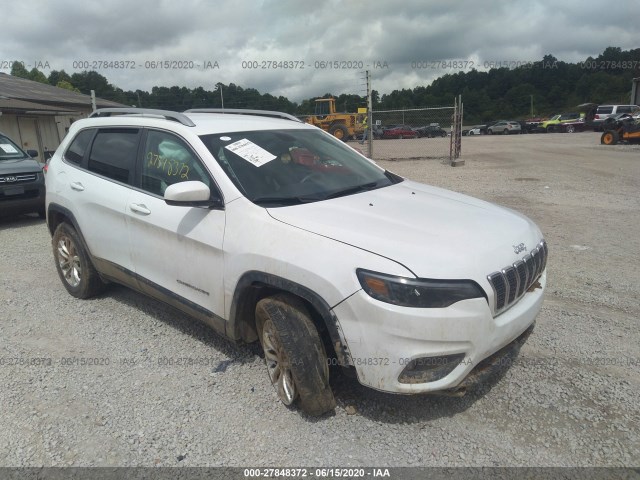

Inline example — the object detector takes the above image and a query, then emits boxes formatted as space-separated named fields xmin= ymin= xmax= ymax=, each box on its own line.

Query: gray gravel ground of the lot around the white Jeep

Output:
xmin=0 ymin=133 xmax=640 ymax=466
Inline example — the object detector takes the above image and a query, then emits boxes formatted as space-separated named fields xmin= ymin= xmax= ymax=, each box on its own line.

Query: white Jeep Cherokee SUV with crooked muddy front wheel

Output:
xmin=46 ymin=109 xmax=547 ymax=415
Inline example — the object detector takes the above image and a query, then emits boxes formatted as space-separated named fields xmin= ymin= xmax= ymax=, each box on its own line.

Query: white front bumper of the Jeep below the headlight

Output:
xmin=334 ymin=271 xmax=546 ymax=394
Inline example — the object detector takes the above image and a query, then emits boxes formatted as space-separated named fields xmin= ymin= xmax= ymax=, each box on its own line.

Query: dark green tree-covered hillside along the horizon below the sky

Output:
xmin=11 ymin=47 xmax=640 ymax=123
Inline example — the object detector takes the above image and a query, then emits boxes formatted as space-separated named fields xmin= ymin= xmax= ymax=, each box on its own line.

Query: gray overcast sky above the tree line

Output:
xmin=0 ymin=0 xmax=640 ymax=101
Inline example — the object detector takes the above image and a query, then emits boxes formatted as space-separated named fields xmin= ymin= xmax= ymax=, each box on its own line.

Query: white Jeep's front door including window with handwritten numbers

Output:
xmin=127 ymin=129 xmax=225 ymax=332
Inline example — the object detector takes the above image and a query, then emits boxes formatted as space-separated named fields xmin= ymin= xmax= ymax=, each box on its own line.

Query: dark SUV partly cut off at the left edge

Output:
xmin=0 ymin=133 xmax=45 ymax=218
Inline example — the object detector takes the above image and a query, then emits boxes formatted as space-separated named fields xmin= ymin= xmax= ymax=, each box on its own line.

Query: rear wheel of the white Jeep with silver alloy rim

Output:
xmin=51 ymin=223 xmax=106 ymax=298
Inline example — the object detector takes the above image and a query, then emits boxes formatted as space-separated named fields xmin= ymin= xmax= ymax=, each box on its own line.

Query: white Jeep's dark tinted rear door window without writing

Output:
xmin=88 ymin=128 xmax=140 ymax=183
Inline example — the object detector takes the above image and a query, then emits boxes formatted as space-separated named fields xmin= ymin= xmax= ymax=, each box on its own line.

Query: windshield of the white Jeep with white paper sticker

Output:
xmin=200 ymin=129 xmax=402 ymax=207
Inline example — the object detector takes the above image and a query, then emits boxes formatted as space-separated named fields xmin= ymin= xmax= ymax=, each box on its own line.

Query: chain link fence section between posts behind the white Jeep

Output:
xmin=356 ymin=106 xmax=454 ymax=160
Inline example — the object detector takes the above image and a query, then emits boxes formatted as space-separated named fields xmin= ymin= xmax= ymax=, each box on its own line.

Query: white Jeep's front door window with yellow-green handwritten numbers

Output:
xmin=140 ymin=130 xmax=211 ymax=196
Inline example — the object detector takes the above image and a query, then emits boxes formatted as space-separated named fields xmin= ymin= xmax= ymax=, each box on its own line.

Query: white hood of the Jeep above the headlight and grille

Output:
xmin=268 ymin=180 xmax=542 ymax=282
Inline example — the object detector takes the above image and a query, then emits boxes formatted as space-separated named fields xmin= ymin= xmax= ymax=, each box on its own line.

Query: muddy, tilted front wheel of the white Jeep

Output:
xmin=256 ymin=294 xmax=336 ymax=416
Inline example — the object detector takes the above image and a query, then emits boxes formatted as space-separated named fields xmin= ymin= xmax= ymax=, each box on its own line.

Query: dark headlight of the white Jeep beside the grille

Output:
xmin=356 ymin=269 xmax=486 ymax=308
